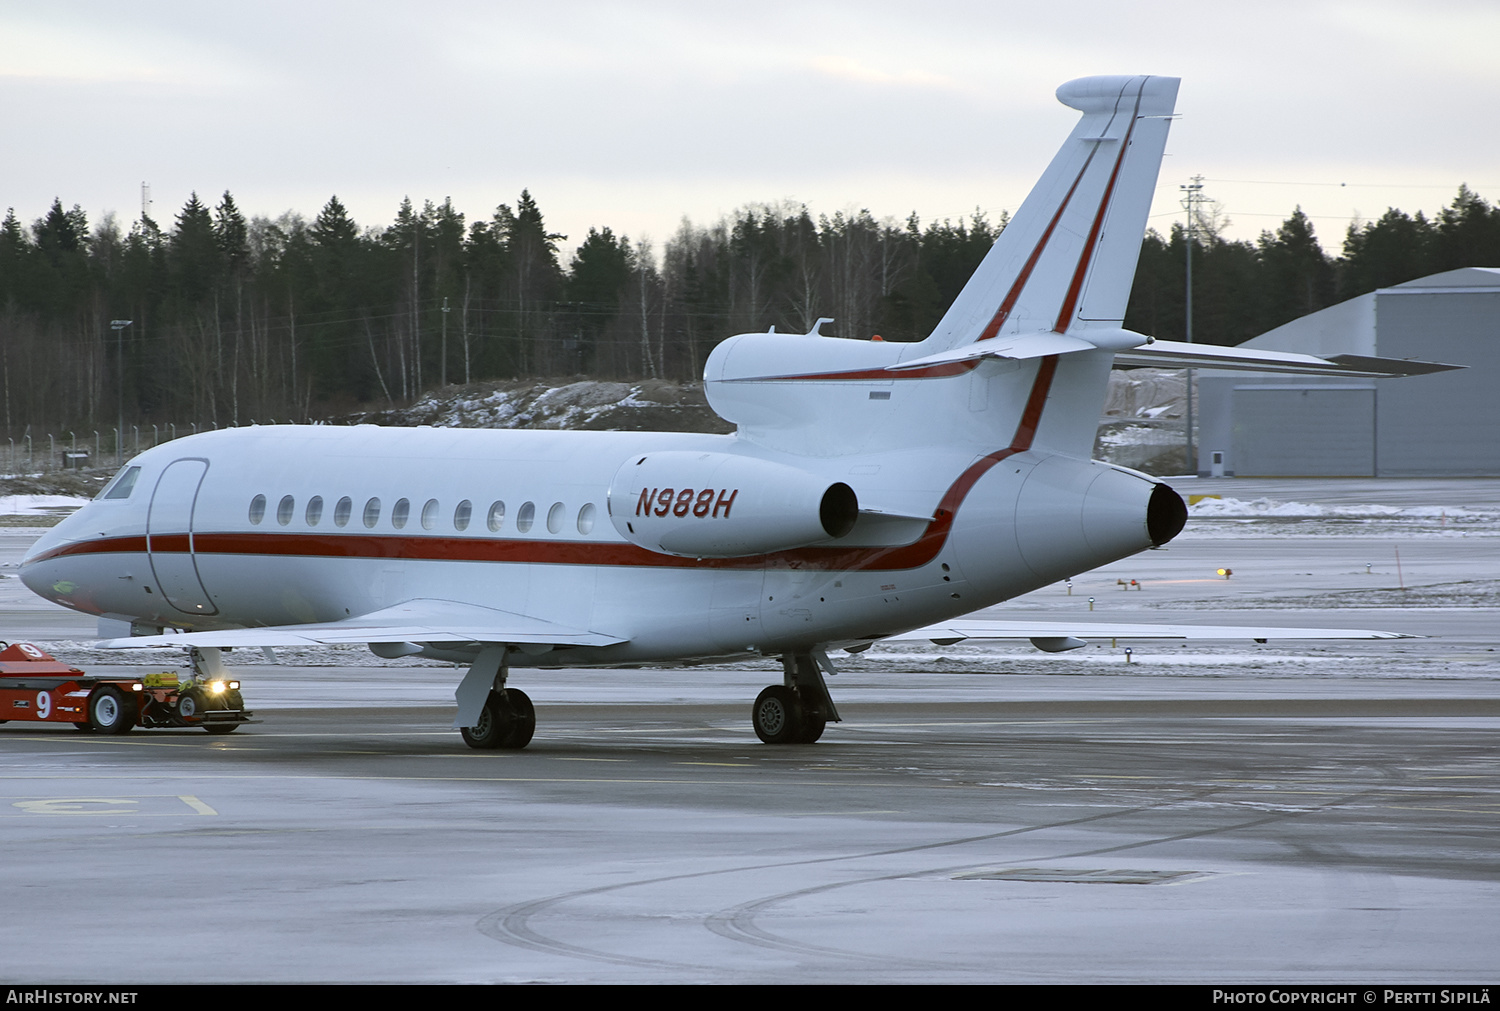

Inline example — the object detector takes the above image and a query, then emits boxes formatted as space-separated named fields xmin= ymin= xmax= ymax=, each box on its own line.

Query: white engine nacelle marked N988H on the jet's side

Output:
xmin=608 ymin=450 xmax=860 ymax=558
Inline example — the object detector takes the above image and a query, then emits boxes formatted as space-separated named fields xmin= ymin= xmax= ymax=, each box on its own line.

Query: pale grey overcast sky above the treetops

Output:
xmin=0 ymin=0 xmax=1500 ymax=259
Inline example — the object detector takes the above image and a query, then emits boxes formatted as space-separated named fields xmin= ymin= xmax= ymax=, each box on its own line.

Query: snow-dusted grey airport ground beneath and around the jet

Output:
xmin=0 ymin=482 xmax=1500 ymax=984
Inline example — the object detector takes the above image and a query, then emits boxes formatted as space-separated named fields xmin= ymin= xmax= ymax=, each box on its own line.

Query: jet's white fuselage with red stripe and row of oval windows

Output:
xmin=23 ymin=408 xmax=1170 ymax=666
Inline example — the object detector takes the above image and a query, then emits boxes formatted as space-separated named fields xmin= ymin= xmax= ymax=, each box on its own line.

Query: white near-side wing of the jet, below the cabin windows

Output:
xmin=99 ymin=600 xmax=627 ymax=650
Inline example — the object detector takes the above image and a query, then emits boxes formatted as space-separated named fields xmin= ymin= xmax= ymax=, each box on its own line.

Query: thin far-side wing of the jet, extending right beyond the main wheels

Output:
xmin=881 ymin=620 xmax=1421 ymax=653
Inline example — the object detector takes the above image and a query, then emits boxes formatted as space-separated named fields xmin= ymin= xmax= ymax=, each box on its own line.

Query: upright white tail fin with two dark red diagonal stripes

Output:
xmin=923 ymin=77 xmax=1178 ymax=354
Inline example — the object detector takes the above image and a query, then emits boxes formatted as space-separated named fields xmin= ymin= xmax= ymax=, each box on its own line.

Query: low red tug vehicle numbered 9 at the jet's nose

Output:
xmin=0 ymin=642 xmax=260 ymax=734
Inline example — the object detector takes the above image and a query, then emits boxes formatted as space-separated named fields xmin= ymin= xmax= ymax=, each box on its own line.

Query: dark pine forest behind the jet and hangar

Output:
xmin=0 ymin=188 xmax=1500 ymax=441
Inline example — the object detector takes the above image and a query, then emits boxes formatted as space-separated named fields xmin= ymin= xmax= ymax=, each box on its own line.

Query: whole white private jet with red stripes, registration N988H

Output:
xmin=21 ymin=77 xmax=1446 ymax=749
